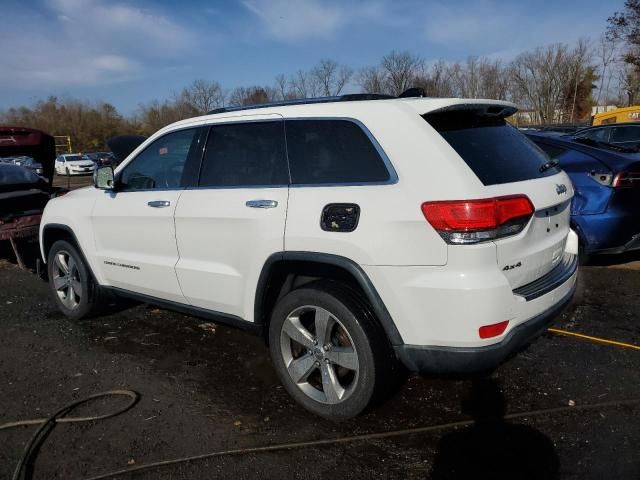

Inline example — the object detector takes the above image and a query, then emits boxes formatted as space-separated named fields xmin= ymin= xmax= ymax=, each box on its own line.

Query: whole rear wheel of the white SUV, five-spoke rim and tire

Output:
xmin=269 ymin=282 xmax=395 ymax=420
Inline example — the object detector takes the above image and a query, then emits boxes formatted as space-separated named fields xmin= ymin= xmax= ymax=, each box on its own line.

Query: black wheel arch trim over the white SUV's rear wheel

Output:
xmin=254 ymin=251 xmax=404 ymax=345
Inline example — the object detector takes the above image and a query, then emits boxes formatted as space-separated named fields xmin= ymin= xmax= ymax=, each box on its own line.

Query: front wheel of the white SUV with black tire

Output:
xmin=47 ymin=240 xmax=101 ymax=320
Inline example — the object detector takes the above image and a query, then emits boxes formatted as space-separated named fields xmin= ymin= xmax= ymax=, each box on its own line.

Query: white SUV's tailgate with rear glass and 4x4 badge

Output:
xmin=425 ymin=111 xmax=573 ymax=288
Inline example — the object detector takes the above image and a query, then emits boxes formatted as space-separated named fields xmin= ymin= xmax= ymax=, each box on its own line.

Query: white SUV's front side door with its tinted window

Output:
xmin=92 ymin=128 xmax=199 ymax=303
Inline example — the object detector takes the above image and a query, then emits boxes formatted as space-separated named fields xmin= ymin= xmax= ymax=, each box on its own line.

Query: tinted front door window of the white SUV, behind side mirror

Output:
xmin=119 ymin=128 xmax=197 ymax=190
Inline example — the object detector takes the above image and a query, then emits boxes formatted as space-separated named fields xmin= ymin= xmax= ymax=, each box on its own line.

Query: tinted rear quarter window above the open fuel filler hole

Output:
xmin=287 ymin=120 xmax=390 ymax=184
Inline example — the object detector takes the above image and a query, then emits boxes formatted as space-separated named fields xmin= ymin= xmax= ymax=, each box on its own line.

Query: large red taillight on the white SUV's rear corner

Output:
xmin=422 ymin=195 xmax=534 ymax=245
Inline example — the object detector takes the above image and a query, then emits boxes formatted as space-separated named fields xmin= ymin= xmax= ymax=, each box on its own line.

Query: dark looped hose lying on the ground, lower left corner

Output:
xmin=0 ymin=390 xmax=140 ymax=480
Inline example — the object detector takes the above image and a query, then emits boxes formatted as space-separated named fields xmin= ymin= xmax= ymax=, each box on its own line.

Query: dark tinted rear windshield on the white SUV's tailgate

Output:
xmin=424 ymin=112 xmax=560 ymax=185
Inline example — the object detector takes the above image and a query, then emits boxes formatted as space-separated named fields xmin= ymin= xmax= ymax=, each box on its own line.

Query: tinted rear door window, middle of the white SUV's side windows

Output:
xmin=200 ymin=122 xmax=289 ymax=187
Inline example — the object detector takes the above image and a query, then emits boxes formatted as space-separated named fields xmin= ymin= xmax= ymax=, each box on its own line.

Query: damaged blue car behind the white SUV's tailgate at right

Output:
xmin=526 ymin=132 xmax=640 ymax=259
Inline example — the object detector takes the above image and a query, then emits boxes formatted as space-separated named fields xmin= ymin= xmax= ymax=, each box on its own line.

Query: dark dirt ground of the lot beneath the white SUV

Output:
xmin=0 ymin=179 xmax=640 ymax=479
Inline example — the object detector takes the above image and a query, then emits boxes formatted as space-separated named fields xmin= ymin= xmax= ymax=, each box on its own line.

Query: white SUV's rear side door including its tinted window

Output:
xmin=175 ymin=115 xmax=289 ymax=320
